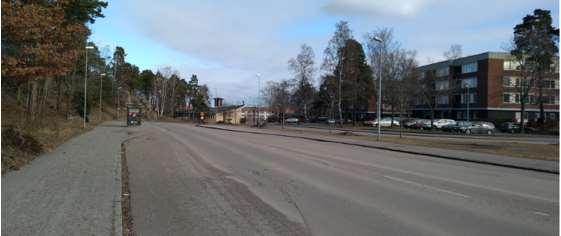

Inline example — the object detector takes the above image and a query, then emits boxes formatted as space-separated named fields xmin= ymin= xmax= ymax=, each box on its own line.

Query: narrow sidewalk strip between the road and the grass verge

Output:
xmin=200 ymin=125 xmax=559 ymax=174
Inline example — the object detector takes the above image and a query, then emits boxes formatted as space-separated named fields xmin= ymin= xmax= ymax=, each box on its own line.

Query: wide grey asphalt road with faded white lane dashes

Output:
xmin=126 ymin=122 xmax=559 ymax=235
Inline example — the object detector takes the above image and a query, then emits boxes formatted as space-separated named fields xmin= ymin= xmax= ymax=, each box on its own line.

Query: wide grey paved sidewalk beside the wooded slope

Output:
xmin=2 ymin=122 xmax=127 ymax=235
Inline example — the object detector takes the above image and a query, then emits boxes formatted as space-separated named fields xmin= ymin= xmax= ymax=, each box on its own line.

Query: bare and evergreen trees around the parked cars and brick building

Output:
xmin=261 ymin=9 xmax=559 ymax=132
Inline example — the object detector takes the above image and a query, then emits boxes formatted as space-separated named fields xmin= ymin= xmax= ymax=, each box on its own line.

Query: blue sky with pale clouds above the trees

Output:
xmin=90 ymin=0 xmax=559 ymax=104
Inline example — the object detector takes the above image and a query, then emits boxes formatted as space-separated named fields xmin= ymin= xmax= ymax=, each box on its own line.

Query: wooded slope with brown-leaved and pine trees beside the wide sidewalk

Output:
xmin=2 ymin=0 xmax=209 ymax=173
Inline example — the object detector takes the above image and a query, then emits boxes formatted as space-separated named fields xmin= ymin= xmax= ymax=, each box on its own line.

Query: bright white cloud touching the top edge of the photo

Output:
xmin=324 ymin=0 xmax=432 ymax=16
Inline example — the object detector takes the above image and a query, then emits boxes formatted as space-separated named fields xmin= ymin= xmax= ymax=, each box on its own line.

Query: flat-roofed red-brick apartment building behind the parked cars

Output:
xmin=411 ymin=52 xmax=559 ymax=122
